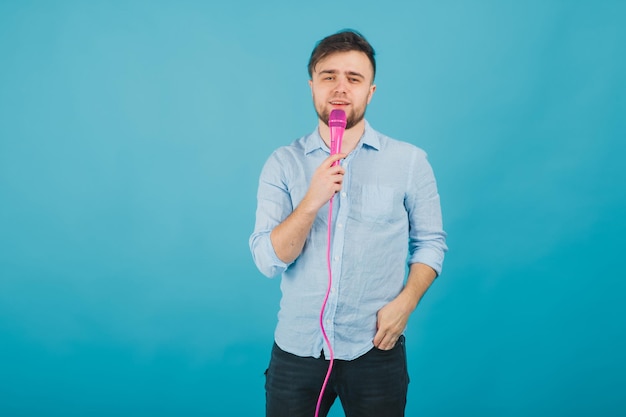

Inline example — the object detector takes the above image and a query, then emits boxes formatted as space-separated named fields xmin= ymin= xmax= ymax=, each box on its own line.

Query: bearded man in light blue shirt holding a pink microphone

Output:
xmin=250 ymin=31 xmax=447 ymax=417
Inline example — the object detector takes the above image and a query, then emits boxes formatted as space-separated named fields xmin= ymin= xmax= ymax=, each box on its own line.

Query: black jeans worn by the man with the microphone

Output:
xmin=265 ymin=336 xmax=409 ymax=417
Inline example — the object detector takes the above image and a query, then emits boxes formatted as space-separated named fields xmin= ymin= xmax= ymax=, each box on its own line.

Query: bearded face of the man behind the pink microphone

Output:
xmin=309 ymin=51 xmax=376 ymax=129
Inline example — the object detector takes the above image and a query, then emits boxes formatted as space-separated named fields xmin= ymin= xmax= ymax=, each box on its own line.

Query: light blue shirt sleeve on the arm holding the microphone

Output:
xmin=249 ymin=152 xmax=293 ymax=278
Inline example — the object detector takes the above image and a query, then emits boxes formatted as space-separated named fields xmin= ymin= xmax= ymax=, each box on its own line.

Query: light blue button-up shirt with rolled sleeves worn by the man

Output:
xmin=250 ymin=122 xmax=447 ymax=360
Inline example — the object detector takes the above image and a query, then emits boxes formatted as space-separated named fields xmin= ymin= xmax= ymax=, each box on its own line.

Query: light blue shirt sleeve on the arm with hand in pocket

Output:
xmin=405 ymin=149 xmax=448 ymax=275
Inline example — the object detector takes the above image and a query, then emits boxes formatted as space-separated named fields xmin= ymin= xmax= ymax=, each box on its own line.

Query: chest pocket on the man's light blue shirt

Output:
xmin=357 ymin=185 xmax=404 ymax=223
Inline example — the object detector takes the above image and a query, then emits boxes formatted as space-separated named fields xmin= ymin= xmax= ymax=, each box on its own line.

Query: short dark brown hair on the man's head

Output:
xmin=308 ymin=29 xmax=376 ymax=81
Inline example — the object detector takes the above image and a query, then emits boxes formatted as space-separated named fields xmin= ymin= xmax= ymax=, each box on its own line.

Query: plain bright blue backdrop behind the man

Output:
xmin=0 ymin=0 xmax=626 ymax=417
